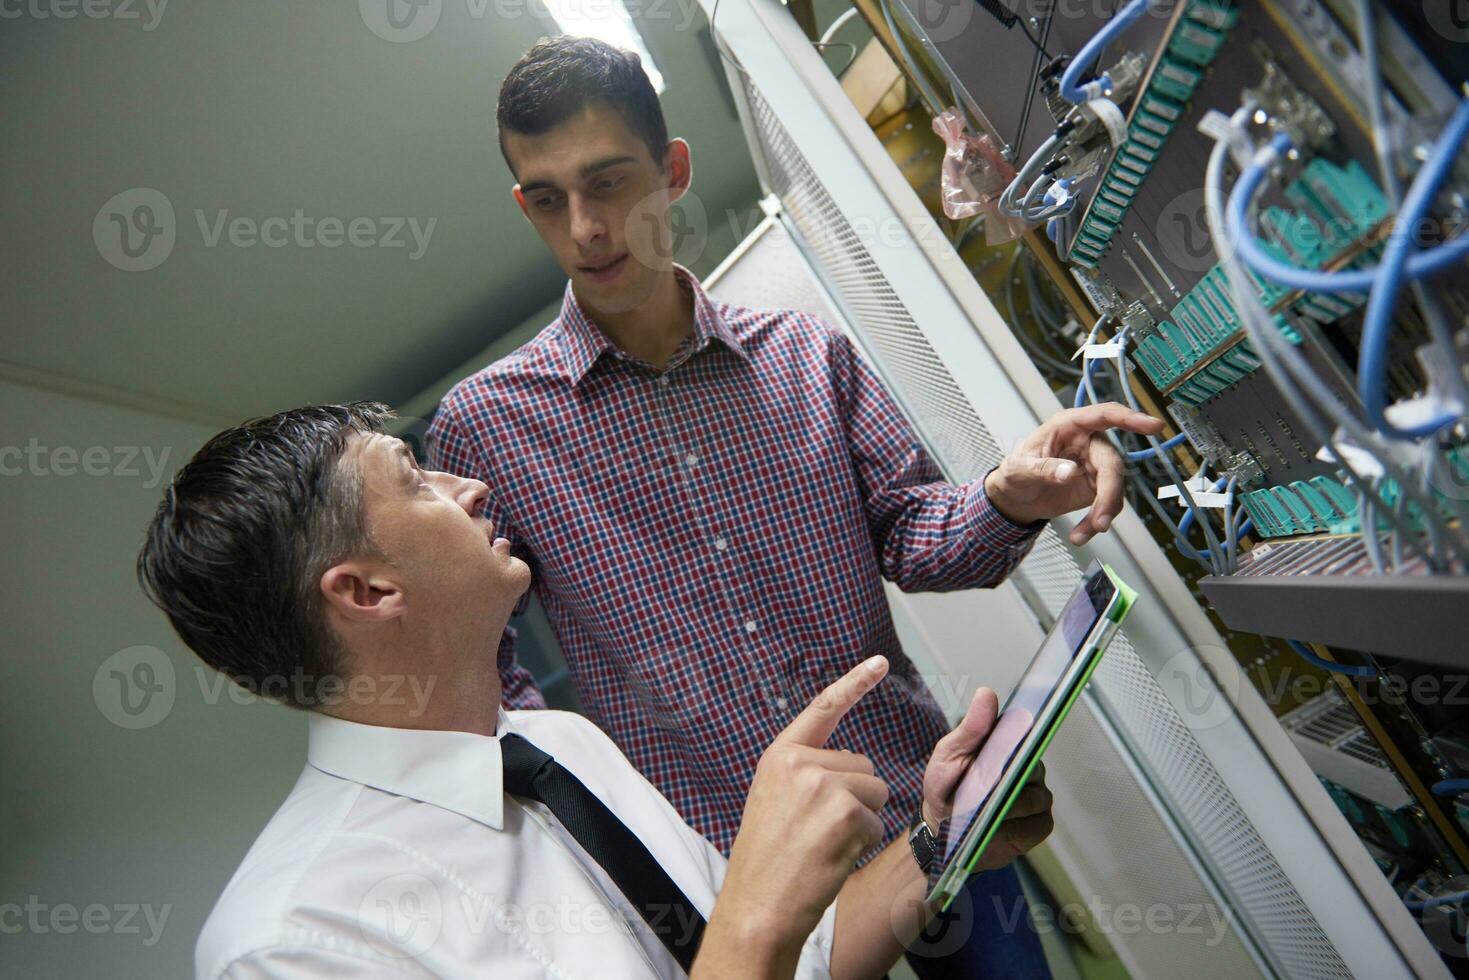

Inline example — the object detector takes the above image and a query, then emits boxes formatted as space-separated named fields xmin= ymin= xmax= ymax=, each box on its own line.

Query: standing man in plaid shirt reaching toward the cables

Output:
xmin=427 ymin=37 xmax=1162 ymax=974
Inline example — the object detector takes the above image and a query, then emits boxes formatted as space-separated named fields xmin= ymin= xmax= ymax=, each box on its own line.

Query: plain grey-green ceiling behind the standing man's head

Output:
xmin=0 ymin=0 xmax=758 ymax=422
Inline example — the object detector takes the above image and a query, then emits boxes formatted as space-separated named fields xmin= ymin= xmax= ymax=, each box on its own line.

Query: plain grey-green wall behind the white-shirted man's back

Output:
xmin=0 ymin=383 xmax=306 ymax=979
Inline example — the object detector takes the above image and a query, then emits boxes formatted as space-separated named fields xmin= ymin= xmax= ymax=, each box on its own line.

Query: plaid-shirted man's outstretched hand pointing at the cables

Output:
xmin=984 ymin=401 xmax=1163 ymax=545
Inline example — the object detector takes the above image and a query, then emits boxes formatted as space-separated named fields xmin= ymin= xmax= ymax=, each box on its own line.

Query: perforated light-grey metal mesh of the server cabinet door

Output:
xmin=739 ymin=73 xmax=1351 ymax=977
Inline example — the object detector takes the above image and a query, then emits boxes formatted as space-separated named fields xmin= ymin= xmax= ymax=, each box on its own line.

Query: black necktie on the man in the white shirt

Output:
xmin=499 ymin=733 xmax=704 ymax=973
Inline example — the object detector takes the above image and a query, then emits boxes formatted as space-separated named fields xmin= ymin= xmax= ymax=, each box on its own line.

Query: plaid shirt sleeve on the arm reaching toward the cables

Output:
xmin=827 ymin=328 xmax=1046 ymax=592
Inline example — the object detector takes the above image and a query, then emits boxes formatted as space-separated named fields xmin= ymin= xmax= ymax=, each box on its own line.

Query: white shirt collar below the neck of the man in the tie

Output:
xmin=306 ymin=710 xmax=510 ymax=830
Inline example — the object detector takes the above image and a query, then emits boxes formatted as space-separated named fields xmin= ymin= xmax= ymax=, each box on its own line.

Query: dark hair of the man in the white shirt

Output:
xmin=138 ymin=401 xmax=394 ymax=708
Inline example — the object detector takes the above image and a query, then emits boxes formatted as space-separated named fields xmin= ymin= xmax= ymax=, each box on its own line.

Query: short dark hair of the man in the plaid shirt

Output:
xmin=495 ymin=34 xmax=668 ymax=173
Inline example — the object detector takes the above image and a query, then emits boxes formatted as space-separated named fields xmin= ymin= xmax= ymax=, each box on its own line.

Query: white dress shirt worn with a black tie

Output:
xmin=194 ymin=711 xmax=836 ymax=980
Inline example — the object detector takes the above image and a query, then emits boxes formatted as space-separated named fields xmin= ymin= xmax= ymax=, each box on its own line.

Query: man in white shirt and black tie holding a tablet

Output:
xmin=138 ymin=403 xmax=1050 ymax=980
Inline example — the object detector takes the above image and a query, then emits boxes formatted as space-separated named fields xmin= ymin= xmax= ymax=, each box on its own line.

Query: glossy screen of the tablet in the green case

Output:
xmin=943 ymin=569 xmax=1112 ymax=864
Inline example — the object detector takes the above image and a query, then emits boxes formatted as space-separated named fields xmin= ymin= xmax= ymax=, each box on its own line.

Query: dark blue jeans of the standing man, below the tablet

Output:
xmin=908 ymin=865 xmax=1050 ymax=980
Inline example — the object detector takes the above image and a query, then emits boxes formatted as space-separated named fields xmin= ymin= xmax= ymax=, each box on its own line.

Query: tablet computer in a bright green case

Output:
xmin=928 ymin=561 xmax=1137 ymax=909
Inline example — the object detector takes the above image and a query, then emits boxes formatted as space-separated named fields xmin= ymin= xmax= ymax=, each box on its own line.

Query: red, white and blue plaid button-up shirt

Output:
xmin=426 ymin=269 xmax=1039 ymax=854
